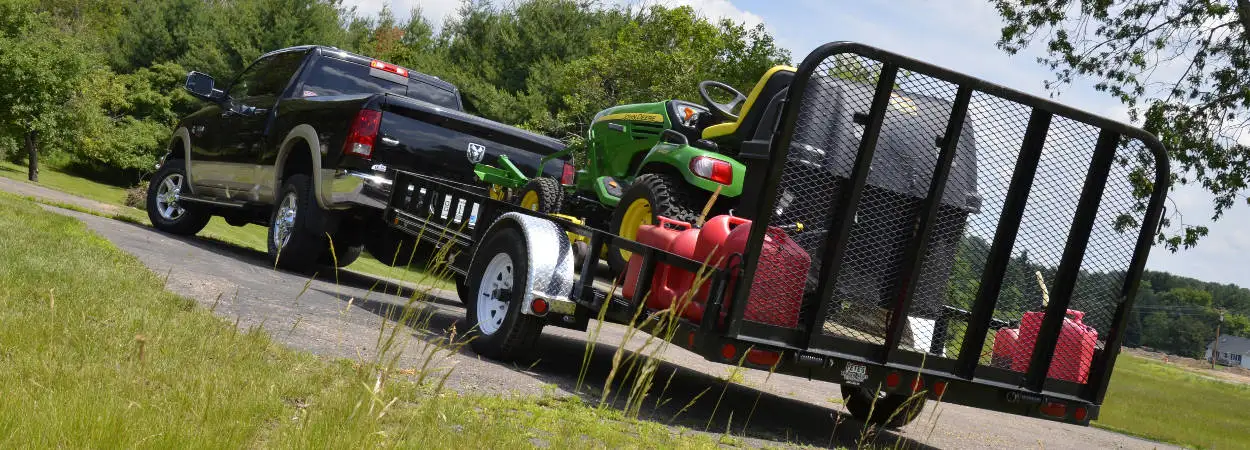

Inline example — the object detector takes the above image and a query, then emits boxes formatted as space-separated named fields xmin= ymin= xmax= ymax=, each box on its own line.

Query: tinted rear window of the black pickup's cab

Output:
xmin=296 ymin=58 xmax=460 ymax=110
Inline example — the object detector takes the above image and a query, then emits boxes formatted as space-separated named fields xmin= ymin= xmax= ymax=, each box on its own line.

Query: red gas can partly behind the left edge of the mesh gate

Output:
xmin=686 ymin=216 xmax=811 ymax=328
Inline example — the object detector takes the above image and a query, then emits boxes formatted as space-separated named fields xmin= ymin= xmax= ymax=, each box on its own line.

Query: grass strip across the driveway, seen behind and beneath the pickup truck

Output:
xmin=0 ymin=161 xmax=455 ymax=290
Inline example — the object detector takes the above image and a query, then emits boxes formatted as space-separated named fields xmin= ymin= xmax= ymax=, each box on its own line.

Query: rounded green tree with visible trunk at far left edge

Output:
xmin=0 ymin=0 xmax=95 ymax=181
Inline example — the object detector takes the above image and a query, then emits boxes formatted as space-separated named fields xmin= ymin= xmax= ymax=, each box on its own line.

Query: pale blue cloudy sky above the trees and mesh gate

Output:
xmin=346 ymin=0 xmax=1250 ymax=286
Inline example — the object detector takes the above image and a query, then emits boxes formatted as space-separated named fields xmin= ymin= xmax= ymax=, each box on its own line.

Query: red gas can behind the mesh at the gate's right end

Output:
xmin=1011 ymin=310 xmax=1098 ymax=384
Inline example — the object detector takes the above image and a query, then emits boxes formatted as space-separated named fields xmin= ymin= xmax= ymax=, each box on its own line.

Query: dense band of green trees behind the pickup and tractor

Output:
xmin=0 ymin=0 xmax=789 ymax=178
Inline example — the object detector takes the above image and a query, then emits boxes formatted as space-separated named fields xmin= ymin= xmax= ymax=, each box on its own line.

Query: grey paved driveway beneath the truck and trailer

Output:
xmin=0 ymin=180 xmax=1166 ymax=449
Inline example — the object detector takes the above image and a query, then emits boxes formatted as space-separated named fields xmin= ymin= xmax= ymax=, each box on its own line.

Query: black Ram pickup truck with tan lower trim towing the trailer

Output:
xmin=146 ymin=46 xmax=564 ymax=269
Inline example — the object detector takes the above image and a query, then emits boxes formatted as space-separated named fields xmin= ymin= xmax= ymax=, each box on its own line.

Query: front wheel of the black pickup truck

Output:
xmin=148 ymin=160 xmax=213 ymax=236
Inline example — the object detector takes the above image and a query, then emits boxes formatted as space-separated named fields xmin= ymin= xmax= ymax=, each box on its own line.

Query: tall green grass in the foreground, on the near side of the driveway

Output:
xmin=0 ymin=194 xmax=716 ymax=449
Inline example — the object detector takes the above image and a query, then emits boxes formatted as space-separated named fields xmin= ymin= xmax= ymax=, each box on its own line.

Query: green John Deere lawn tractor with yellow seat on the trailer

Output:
xmin=475 ymin=66 xmax=795 ymax=274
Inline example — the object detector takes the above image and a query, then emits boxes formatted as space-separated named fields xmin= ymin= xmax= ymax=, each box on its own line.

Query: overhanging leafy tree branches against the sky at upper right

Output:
xmin=993 ymin=0 xmax=1250 ymax=251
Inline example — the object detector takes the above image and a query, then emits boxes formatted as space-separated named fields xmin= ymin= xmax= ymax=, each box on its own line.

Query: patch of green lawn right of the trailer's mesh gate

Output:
xmin=1094 ymin=354 xmax=1250 ymax=449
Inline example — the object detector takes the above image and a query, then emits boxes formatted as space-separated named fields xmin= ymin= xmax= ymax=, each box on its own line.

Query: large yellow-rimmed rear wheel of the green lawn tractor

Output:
xmin=608 ymin=174 xmax=703 ymax=275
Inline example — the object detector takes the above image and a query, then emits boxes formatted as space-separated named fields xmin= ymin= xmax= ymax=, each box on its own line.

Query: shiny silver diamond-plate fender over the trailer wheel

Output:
xmin=470 ymin=213 xmax=576 ymax=315
